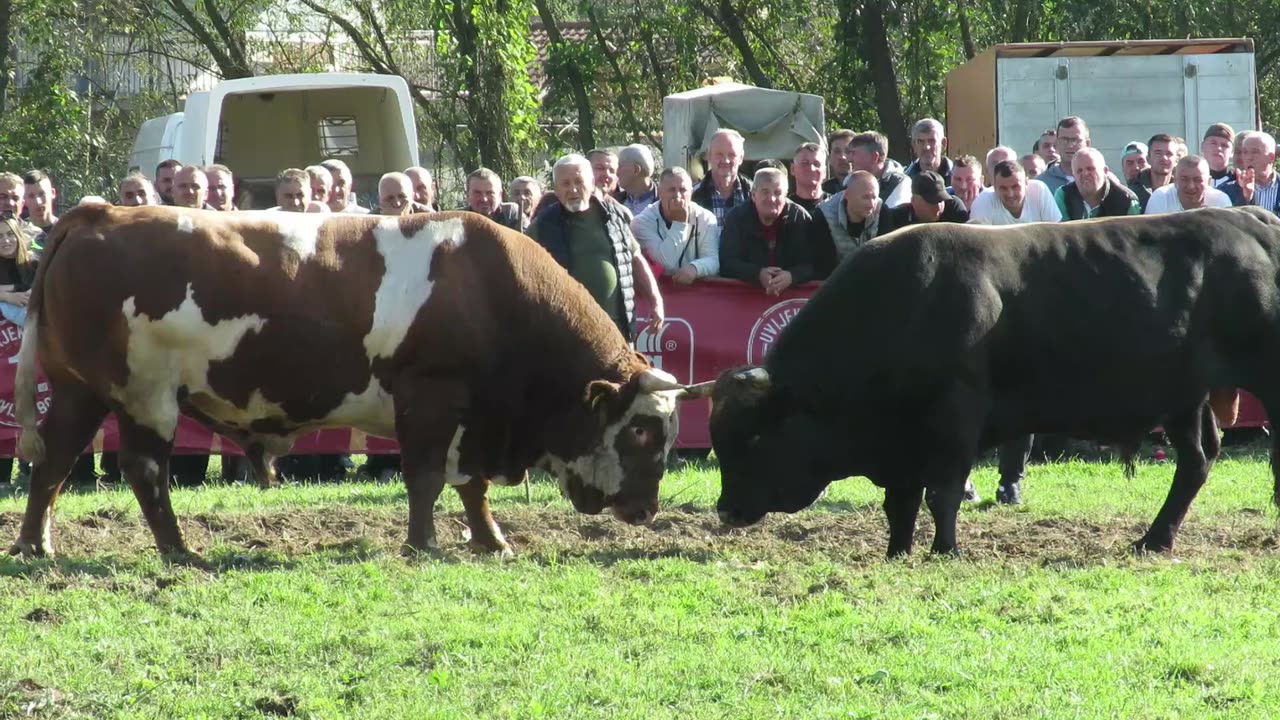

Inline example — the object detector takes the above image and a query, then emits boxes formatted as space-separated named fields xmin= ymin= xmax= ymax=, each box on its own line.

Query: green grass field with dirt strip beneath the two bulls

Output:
xmin=0 ymin=448 xmax=1280 ymax=720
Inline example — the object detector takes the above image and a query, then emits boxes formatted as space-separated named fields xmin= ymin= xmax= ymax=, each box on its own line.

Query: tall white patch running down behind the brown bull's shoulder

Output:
xmin=365 ymin=212 xmax=462 ymax=360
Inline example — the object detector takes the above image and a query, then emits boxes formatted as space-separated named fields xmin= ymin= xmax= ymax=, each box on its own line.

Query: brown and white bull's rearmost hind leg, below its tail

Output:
xmin=9 ymin=384 xmax=108 ymax=557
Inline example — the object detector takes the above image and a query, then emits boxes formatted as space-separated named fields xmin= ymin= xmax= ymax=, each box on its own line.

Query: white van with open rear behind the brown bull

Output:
xmin=129 ymin=73 xmax=419 ymax=209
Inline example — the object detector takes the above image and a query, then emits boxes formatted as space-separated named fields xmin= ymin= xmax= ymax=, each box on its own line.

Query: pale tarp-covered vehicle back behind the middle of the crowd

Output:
xmin=662 ymin=83 xmax=827 ymax=175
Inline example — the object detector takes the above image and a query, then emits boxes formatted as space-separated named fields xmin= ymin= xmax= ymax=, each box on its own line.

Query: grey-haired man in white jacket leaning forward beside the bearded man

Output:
xmin=631 ymin=167 xmax=721 ymax=284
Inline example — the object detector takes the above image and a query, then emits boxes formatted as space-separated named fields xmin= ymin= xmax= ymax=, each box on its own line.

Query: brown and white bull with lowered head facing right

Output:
xmin=12 ymin=205 xmax=711 ymax=555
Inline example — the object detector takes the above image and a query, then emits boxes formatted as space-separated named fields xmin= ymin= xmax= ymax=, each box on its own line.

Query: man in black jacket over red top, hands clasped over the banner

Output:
xmin=719 ymin=168 xmax=835 ymax=295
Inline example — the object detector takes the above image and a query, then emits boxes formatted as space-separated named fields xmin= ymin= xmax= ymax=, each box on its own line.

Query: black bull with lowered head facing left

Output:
xmin=710 ymin=208 xmax=1280 ymax=555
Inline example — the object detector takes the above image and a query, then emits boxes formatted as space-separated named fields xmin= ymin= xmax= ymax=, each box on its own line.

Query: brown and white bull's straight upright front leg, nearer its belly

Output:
xmin=392 ymin=375 xmax=466 ymax=553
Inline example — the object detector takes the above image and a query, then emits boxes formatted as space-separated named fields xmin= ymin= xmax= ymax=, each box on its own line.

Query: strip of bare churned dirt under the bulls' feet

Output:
xmin=0 ymin=505 xmax=1277 ymax=571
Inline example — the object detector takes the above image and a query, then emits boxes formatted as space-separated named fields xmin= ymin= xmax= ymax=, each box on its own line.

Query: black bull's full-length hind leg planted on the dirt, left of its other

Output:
xmin=1134 ymin=402 xmax=1221 ymax=552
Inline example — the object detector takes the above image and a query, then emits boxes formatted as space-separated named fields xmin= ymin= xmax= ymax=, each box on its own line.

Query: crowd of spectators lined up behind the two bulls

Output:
xmin=0 ymin=117 xmax=1280 ymax=487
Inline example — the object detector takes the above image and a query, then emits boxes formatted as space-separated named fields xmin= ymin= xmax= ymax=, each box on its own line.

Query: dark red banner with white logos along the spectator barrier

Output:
xmin=0 ymin=279 xmax=1267 ymax=457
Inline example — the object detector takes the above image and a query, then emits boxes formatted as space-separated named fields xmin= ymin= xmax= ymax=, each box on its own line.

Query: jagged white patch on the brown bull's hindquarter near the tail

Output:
xmin=111 ymin=283 xmax=266 ymax=439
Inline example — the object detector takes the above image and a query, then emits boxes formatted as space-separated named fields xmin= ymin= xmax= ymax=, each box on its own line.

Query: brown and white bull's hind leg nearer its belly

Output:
xmin=116 ymin=414 xmax=191 ymax=556
